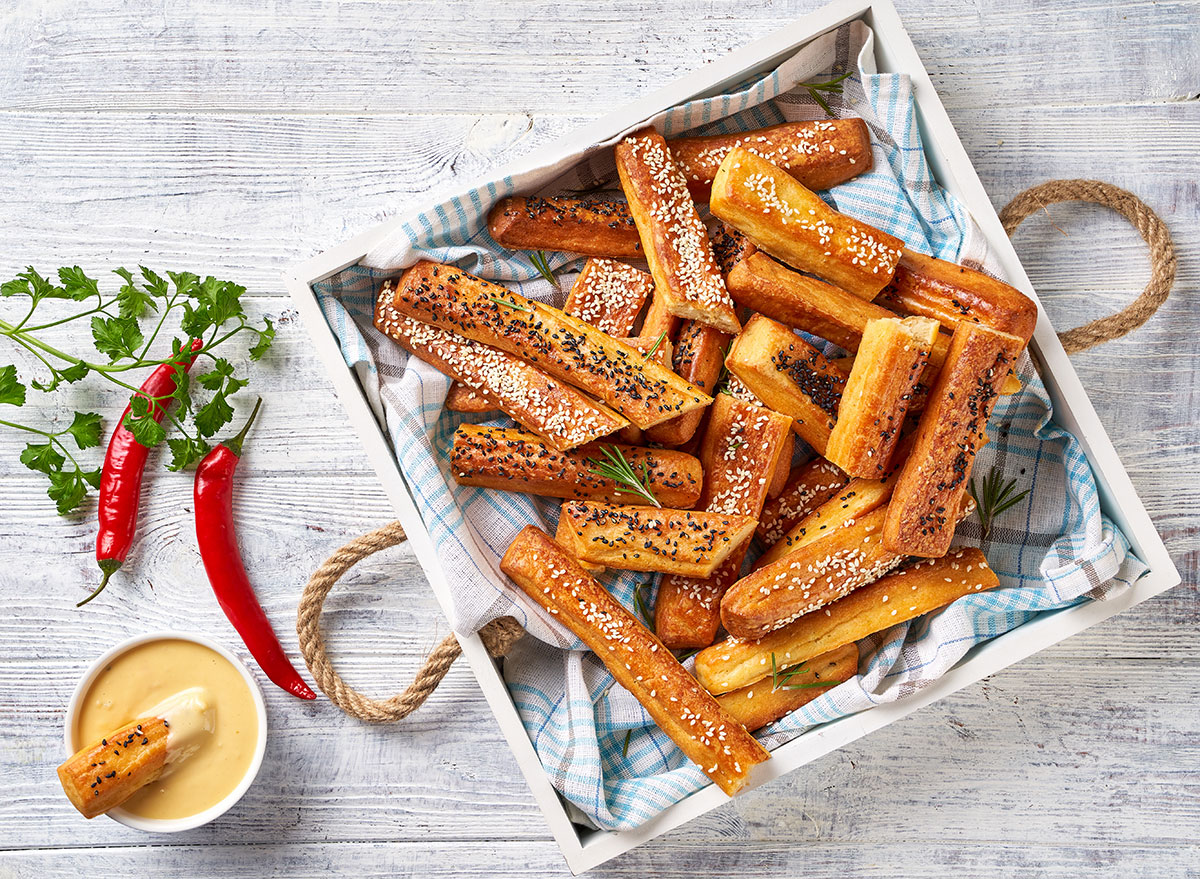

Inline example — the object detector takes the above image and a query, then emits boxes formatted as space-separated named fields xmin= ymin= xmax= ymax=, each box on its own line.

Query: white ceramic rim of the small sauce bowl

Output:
xmin=62 ymin=632 xmax=266 ymax=833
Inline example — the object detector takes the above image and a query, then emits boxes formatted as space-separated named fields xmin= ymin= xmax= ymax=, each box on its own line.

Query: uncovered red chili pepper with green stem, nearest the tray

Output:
xmin=196 ymin=400 xmax=317 ymax=699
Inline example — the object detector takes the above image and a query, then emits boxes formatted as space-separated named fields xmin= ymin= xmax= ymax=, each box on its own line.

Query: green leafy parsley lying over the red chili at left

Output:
xmin=0 ymin=265 xmax=275 ymax=515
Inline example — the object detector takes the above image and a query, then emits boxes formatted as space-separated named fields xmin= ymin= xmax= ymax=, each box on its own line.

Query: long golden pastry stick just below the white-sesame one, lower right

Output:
xmin=696 ymin=548 xmax=1000 ymax=693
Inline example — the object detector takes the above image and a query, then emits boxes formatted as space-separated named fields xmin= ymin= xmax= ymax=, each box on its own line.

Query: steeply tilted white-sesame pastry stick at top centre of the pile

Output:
xmin=616 ymin=128 xmax=742 ymax=333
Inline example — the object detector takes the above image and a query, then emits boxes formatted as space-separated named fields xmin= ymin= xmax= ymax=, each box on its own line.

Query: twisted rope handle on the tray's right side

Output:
xmin=1000 ymin=180 xmax=1176 ymax=354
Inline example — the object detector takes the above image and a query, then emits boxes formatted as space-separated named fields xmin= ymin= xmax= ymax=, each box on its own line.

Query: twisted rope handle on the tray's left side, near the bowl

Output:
xmin=296 ymin=522 xmax=524 ymax=723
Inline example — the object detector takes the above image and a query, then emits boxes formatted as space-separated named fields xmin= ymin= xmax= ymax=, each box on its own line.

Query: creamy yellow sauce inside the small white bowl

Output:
xmin=72 ymin=639 xmax=258 ymax=818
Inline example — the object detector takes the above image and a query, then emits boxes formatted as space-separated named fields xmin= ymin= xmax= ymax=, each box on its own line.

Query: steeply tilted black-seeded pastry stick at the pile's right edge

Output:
xmin=883 ymin=322 xmax=1025 ymax=558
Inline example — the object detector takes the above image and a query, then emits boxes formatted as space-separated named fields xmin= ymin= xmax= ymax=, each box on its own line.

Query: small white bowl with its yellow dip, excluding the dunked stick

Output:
xmin=64 ymin=632 xmax=266 ymax=833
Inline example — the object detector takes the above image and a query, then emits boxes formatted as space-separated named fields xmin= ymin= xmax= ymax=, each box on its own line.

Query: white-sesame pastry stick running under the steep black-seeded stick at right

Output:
xmin=721 ymin=497 xmax=974 ymax=638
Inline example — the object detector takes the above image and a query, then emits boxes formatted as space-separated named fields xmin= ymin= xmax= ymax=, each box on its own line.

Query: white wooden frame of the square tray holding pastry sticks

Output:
xmin=286 ymin=0 xmax=1180 ymax=873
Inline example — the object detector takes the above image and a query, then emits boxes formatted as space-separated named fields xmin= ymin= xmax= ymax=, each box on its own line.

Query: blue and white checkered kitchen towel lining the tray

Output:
xmin=314 ymin=22 xmax=1145 ymax=830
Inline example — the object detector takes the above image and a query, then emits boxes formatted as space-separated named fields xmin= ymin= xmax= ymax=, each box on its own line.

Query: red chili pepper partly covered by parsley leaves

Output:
xmin=85 ymin=339 xmax=204 ymax=608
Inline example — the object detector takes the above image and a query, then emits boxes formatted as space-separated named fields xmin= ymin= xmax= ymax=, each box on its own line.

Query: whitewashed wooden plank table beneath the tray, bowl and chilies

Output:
xmin=0 ymin=0 xmax=1200 ymax=878
